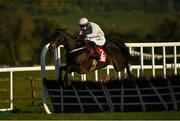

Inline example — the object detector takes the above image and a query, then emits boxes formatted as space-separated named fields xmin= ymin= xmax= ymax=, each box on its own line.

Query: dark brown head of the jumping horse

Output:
xmin=49 ymin=28 xmax=66 ymax=49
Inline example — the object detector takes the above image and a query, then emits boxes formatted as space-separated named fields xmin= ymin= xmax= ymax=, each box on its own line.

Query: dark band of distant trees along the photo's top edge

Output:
xmin=0 ymin=0 xmax=180 ymax=12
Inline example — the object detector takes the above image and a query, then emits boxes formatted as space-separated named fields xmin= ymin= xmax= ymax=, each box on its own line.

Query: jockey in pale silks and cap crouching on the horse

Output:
xmin=79 ymin=18 xmax=106 ymax=61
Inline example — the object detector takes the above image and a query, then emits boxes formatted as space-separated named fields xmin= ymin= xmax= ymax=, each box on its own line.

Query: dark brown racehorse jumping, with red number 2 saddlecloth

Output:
xmin=49 ymin=28 xmax=136 ymax=85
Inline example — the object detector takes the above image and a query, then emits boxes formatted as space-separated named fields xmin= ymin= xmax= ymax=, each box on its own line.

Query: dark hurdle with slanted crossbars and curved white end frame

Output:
xmin=41 ymin=44 xmax=180 ymax=114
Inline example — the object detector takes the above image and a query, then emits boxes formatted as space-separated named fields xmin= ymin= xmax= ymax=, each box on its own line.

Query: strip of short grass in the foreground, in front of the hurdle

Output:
xmin=0 ymin=112 xmax=180 ymax=120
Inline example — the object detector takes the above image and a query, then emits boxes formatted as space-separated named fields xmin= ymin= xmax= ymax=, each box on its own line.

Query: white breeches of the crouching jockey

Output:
xmin=88 ymin=36 xmax=106 ymax=46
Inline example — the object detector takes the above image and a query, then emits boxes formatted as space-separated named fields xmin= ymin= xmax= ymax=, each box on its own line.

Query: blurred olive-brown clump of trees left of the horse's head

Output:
xmin=0 ymin=11 xmax=57 ymax=65
